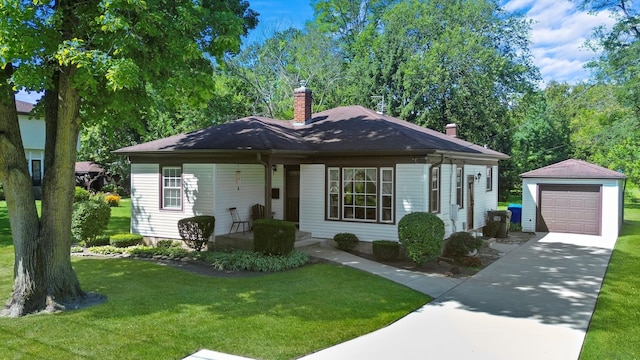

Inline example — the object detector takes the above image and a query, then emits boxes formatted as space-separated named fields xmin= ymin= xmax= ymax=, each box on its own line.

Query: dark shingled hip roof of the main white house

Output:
xmin=115 ymin=106 xmax=508 ymax=159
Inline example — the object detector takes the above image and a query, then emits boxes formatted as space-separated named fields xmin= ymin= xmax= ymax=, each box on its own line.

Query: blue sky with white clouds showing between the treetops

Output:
xmin=16 ymin=0 xmax=614 ymax=103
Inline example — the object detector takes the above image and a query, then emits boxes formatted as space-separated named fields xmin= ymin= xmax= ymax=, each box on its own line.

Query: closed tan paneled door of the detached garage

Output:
xmin=536 ymin=185 xmax=602 ymax=235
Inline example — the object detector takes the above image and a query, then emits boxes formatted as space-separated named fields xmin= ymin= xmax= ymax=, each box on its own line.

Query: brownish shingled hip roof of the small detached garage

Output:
xmin=520 ymin=159 xmax=626 ymax=179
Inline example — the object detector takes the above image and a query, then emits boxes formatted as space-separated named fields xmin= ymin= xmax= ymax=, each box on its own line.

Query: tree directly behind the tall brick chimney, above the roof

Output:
xmin=227 ymin=28 xmax=344 ymax=119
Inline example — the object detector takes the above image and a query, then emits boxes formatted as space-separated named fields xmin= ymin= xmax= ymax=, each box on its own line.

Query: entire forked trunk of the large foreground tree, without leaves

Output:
xmin=0 ymin=68 xmax=95 ymax=317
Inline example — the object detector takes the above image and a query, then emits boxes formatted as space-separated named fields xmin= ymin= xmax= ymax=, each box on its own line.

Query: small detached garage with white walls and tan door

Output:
xmin=520 ymin=159 xmax=626 ymax=237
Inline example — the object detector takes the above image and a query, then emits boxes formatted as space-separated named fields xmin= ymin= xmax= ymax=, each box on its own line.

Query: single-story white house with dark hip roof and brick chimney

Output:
xmin=115 ymin=87 xmax=508 ymax=241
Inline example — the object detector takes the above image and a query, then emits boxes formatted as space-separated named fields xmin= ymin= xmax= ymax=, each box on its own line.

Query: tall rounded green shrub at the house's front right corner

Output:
xmin=398 ymin=212 xmax=444 ymax=266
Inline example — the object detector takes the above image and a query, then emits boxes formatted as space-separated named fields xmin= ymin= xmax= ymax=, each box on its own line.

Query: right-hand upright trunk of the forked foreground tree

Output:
xmin=40 ymin=67 xmax=85 ymax=307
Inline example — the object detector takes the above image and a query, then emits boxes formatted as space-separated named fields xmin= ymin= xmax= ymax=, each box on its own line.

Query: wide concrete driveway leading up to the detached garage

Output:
xmin=303 ymin=233 xmax=616 ymax=360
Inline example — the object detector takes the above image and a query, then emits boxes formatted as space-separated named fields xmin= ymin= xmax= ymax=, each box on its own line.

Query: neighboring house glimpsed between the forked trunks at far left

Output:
xmin=16 ymin=100 xmax=46 ymax=195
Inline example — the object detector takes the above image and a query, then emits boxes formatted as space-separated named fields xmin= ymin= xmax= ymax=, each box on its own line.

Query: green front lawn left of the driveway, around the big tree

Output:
xmin=0 ymin=198 xmax=430 ymax=359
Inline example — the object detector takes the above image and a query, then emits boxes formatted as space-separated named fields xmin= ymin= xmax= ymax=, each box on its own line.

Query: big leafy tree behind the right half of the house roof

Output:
xmin=347 ymin=0 xmax=538 ymax=151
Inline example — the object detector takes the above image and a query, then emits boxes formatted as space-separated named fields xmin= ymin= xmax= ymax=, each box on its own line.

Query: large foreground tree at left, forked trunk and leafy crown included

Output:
xmin=0 ymin=0 xmax=257 ymax=316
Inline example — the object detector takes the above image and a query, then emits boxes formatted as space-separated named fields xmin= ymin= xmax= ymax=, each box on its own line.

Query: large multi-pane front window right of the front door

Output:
xmin=327 ymin=167 xmax=394 ymax=223
